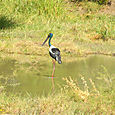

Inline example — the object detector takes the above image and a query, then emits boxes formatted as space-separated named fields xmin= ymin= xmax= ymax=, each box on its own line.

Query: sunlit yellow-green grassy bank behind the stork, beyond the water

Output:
xmin=0 ymin=0 xmax=115 ymax=59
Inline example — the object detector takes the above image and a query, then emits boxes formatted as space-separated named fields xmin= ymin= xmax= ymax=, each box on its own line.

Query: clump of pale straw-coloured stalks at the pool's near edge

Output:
xmin=63 ymin=76 xmax=100 ymax=102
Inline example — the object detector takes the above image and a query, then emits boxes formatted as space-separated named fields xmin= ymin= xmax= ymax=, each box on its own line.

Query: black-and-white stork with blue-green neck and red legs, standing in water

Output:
xmin=42 ymin=33 xmax=62 ymax=78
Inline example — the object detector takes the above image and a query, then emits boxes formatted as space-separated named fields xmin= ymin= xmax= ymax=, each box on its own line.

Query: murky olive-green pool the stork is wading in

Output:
xmin=0 ymin=55 xmax=115 ymax=96
